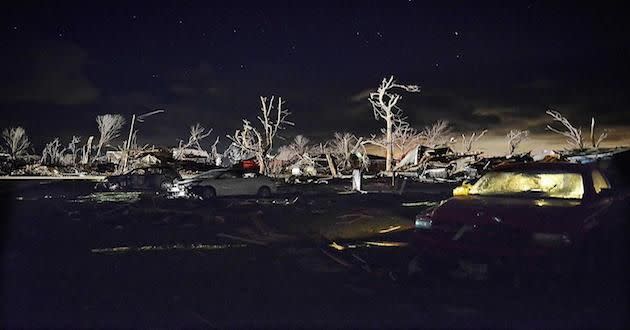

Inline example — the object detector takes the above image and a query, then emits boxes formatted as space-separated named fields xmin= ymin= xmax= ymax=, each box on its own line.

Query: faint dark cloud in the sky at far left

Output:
xmin=0 ymin=42 xmax=100 ymax=105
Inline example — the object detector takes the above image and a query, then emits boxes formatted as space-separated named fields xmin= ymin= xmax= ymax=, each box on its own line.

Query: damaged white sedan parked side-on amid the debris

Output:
xmin=170 ymin=169 xmax=278 ymax=199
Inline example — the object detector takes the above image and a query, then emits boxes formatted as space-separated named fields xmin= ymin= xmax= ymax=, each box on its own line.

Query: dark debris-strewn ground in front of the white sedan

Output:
xmin=1 ymin=182 xmax=628 ymax=329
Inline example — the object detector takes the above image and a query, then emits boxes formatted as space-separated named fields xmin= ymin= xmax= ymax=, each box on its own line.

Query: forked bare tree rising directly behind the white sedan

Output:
xmin=227 ymin=96 xmax=293 ymax=173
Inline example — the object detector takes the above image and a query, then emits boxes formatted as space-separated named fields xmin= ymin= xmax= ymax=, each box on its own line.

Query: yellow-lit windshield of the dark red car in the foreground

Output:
xmin=469 ymin=172 xmax=584 ymax=199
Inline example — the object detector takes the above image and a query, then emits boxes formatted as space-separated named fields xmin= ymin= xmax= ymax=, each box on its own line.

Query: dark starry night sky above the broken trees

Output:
xmin=0 ymin=1 xmax=630 ymax=152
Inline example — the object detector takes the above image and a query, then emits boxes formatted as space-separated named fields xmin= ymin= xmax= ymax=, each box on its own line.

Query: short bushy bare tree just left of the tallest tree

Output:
xmin=326 ymin=132 xmax=369 ymax=171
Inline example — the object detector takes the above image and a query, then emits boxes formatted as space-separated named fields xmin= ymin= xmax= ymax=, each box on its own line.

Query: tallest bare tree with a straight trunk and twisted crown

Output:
xmin=368 ymin=76 xmax=420 ymax=172
